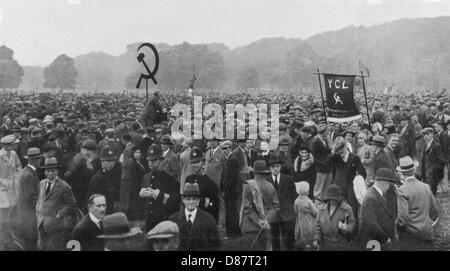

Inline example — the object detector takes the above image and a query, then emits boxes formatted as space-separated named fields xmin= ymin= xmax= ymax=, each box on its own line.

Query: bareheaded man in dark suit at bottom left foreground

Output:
xmin=72 ymin=194 xmax=106 ymax=251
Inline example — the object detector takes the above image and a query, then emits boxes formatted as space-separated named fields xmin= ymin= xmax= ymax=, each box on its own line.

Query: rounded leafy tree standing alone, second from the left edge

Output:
xmin=44 ymin=54 xmax=77 ymax=91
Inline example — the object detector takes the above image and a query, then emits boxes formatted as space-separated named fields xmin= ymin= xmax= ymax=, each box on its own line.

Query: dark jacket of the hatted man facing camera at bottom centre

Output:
xmin=169 ymin=209 xmax=220 ymax=251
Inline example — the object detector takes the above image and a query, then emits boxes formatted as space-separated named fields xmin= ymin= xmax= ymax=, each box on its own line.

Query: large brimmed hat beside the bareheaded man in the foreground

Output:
xmin=97 ymin=213 xmax=141 ymax=239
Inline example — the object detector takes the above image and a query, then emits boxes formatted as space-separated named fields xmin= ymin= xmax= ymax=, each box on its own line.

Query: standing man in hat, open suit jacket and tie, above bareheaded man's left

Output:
xmin=36 ymin=157 xmax=75 ymax=250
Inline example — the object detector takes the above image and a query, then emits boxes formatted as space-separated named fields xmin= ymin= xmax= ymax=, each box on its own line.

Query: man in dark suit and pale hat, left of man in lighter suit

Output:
xmin=17 ymin=148 xmax=42 ymax=251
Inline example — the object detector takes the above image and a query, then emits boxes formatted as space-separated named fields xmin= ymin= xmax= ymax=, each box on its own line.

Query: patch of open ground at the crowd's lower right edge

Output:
xmin=434 ymin=192 xmax=450 ymax=251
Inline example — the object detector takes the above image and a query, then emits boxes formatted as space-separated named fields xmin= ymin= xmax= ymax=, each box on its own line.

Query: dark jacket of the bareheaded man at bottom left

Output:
xmin=72 ymin=214 xmax=105 ymax=251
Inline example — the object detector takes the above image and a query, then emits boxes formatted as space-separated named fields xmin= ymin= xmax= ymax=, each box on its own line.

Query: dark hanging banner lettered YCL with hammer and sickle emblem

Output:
xmin=323 ymin=74 xmax=362 ymax=122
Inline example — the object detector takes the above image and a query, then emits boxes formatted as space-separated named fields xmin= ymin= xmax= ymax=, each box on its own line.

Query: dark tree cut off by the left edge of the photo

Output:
xmin=0 ymin=45 xmax=23 ymax=88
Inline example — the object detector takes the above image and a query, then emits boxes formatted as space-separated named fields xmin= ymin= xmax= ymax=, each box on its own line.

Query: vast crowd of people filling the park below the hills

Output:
xmin=0 ymin=90 xmax=450 ymax=251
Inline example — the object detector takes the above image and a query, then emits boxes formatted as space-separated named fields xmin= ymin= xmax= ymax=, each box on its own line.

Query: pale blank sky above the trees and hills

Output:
xmin=0 ymin=0 xmax=450 ymax=66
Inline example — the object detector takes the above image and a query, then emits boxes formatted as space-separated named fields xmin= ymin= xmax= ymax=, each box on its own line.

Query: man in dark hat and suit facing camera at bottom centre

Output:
xmin=169 ymin=183 xmax=220 ymax=251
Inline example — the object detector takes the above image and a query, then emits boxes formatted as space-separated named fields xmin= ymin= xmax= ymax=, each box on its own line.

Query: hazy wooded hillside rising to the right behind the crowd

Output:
xmin=22 ymin=17 xmax=450 ymax=90
